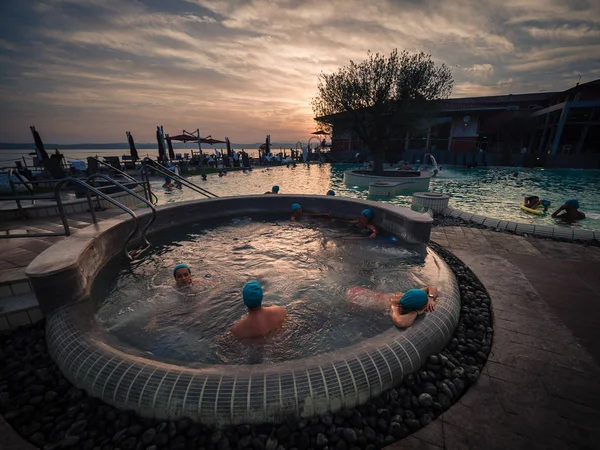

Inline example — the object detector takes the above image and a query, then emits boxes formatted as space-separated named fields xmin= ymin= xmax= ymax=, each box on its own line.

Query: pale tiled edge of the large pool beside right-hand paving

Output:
xmin=439 ymin=207 xmax=600 ymax=242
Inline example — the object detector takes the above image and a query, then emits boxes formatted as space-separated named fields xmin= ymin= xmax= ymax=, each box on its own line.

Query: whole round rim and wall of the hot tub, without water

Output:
xmin=27 ymin=195 xmax=460 ymax=426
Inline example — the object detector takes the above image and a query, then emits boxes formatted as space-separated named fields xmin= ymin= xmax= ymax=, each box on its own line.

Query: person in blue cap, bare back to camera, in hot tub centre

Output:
xmin=231 ymin=280 xmax=287 ymax=339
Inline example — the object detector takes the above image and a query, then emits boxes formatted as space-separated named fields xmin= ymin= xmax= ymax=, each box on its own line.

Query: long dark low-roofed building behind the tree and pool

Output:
xmin=328 ymin=80 xmax=600 ymax=168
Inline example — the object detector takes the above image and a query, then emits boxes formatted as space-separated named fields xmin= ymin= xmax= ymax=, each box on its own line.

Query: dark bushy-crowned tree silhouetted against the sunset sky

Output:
xmin=312 ymin=49 xmax=453 ymax=174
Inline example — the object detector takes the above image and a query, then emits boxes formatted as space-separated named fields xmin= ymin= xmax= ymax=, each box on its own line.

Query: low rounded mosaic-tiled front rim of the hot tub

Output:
xmin=47 ymin=252 xmax=460 ymax=426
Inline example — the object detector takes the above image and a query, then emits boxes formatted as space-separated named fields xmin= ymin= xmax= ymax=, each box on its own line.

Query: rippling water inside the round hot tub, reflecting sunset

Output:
xmin=93 ymin=219 xmax=437 ymax=364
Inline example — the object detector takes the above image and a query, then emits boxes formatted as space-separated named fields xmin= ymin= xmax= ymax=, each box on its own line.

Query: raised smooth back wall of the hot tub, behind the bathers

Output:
xmin=26 ymin=195 xmax=433 ymax=315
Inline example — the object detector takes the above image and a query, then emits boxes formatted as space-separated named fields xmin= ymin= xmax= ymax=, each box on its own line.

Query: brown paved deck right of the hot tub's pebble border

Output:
xmin=388 ymin=227 xmax=600 ymax=450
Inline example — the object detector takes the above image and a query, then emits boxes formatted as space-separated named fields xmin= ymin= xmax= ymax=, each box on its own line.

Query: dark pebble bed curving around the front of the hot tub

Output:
xmin=0 ymin=244 xmax=493 ymax=450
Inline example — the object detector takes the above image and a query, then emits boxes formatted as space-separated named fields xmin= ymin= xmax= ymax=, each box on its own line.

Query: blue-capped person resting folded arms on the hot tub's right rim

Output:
xmin=346 ymin=286 xmax=438 ymax=328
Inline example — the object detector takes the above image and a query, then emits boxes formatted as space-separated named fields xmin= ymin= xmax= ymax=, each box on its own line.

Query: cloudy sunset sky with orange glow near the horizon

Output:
xmin=0 ymin=0 xmax=600 ymax=144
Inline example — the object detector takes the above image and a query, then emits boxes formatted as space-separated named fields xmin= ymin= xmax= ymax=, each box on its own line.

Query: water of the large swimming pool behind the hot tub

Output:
xmin=153 ymin=164 xmax=600 ymax=230
